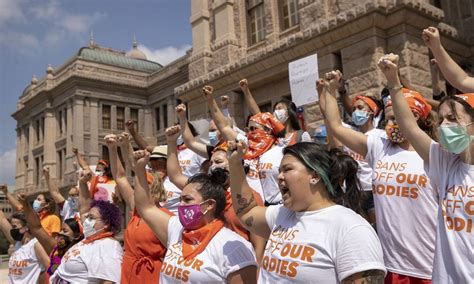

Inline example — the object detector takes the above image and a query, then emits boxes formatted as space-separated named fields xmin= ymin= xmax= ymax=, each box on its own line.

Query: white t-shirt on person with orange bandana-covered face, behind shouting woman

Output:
xmin=257 ymin=145 xmax=285 ymax=204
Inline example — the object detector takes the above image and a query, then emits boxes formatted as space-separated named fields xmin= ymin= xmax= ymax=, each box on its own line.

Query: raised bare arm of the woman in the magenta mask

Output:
xmin=134 ymin=150 xmax=170 ymax=245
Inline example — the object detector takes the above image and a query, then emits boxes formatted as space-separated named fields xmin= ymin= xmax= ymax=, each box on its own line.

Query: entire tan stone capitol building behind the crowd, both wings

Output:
xmin=12 ymin=0 xmax=474 ymax=192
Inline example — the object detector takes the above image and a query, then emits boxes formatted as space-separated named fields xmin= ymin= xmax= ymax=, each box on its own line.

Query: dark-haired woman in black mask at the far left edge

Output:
xmin=0 ymin=202 xmax=49 ymax=283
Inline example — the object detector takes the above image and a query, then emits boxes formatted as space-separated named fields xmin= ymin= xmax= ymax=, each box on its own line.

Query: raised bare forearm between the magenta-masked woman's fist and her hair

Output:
xmin=165 ymin=126 xmax=188 ymax=189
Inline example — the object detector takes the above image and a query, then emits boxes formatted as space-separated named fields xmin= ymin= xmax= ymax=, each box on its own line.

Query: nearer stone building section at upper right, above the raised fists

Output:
xmin=175 ymin=0 xmax=474 ymax=130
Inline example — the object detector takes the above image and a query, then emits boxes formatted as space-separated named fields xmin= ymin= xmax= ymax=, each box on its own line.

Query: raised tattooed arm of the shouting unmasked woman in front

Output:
xmin=227 ymin=140 xmax=270 ymax=239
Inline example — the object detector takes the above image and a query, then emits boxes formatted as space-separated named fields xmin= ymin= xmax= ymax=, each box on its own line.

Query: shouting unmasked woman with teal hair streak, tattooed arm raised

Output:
xmin=228 ymin=141 xmax=385 ymax=283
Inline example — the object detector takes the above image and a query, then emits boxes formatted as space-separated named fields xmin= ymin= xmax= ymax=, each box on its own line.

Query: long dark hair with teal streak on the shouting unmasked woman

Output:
xmin=283 ymin=142 xmax=362 ymax=213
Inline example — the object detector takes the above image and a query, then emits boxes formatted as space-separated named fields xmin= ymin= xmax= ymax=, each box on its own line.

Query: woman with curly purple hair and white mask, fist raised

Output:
xmin=51 ymin=170 xmax=123 ymax=284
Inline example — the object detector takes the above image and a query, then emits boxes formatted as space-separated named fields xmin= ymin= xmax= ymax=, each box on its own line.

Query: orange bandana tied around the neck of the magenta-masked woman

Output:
xmin=183 ymin=219 xmax=224 ymax=260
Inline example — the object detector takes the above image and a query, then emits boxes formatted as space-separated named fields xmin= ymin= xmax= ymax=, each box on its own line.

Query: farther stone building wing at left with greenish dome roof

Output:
xmin=13 ymin=44 xmax=188 ymax=192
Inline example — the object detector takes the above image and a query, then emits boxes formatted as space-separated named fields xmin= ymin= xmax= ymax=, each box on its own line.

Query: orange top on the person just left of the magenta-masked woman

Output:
xmin=121 ymin=208 xmax=173 ymax=284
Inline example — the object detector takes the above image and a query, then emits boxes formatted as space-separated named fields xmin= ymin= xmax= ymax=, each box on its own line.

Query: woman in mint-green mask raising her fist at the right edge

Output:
xmin=379 ymin=53 xmax=474 ymax=284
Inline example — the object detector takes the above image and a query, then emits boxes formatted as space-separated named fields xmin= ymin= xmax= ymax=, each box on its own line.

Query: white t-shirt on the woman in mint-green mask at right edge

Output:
xmin=428 ymin=142 xmax=474 ymax=284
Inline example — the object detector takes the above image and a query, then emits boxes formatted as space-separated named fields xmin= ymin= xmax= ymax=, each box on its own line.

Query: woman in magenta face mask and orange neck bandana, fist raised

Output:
xmin=134 ymin=151 xmax=257 ymax=283
